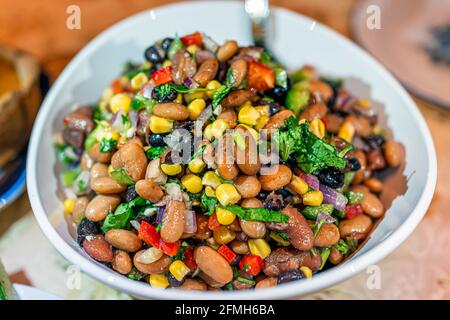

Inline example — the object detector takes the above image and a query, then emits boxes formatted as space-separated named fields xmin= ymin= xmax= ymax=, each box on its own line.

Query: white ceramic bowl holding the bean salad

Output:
xmin=27 ymin=1 xmax=436 ymax=299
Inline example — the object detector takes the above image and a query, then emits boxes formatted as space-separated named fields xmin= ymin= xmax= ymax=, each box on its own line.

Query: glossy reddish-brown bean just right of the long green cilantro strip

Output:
xmin=282 ymin=207 xmax=314 ymax=250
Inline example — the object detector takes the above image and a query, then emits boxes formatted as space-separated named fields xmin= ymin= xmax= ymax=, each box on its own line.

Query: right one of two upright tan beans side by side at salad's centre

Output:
xmin=235 ymin=126 xmax=261 ymax=176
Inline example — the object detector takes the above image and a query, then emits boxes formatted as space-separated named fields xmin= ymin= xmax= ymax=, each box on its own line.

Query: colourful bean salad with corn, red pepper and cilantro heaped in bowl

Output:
xmin=55 ymin=32 xmax=404 ymax=290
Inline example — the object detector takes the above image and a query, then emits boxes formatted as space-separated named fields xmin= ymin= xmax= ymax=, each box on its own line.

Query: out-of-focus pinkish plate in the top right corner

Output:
xmin=351 ymin=0 xmax=450 ymax=109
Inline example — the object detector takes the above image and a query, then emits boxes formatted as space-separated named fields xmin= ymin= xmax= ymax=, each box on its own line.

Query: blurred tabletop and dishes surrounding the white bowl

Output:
xmin=0 ymin=0 xmax=450 ymax=299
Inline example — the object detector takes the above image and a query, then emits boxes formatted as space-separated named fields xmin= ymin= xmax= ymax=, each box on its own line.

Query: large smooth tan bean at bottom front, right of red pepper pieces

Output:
xmin=194 ymin=246 xmax=233 ymax=286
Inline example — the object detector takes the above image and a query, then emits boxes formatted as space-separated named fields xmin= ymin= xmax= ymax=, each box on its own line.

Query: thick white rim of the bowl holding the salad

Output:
xmin=27 ymin=1 xmax=437 ymax=300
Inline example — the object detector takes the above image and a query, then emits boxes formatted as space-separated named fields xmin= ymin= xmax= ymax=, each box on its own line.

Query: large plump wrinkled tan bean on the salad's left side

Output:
xmin=111 ymin=142 xmax=147 ymax=181
